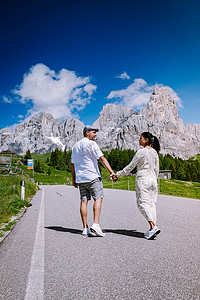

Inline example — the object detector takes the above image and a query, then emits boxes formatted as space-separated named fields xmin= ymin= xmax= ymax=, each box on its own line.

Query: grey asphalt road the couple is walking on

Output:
xmin=0 ymin=186 xmax=200 ymax=300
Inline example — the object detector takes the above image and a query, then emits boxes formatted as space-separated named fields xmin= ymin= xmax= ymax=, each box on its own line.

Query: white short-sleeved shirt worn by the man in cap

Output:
xmin=71 ymin=137 xmax=103 ymax=183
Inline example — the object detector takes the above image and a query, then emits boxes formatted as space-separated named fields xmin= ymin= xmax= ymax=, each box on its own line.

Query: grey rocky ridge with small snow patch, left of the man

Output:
xmin=0 ymin=112 xmax=84 ymax=155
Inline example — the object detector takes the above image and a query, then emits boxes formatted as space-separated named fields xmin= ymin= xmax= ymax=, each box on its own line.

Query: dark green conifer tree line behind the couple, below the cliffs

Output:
xmin=24 ymin=148 xmax=200 ymax=182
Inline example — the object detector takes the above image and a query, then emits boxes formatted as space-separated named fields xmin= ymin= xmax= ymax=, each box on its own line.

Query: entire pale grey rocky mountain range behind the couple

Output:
xmin=0 ymin=87 xmax=200 ymax=159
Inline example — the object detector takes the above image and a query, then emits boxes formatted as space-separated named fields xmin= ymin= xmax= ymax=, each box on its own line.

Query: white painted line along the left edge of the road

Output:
xmin=24 ymin=190 xmax=44 ymax=300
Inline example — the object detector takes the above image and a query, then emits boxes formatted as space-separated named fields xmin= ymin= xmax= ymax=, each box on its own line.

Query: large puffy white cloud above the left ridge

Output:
xmin=12 ymin=64 xmax=97 ymax=119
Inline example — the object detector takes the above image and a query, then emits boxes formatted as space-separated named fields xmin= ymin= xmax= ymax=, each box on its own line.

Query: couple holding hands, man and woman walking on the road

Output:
xmin=71 ymin=125 xmax=160 ymax=240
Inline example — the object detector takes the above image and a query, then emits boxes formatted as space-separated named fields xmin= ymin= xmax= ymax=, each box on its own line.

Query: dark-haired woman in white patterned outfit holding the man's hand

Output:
xmin=113 ymin=132 xmax=160 ymax=240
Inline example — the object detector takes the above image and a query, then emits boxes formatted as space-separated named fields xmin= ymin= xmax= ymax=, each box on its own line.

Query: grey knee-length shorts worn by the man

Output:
xmin=78 ymin=177 xmax=103 ymax=201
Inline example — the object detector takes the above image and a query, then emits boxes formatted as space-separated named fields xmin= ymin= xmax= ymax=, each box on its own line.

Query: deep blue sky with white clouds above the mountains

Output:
xmin=0 ymin=0 xmax=200 ymax=128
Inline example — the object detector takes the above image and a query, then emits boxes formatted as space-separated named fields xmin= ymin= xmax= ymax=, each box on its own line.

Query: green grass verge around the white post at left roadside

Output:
xmin=0 ymin=175 xmax=37 ymax=226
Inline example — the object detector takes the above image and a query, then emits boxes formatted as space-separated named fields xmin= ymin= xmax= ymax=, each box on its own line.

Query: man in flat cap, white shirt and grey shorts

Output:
xmin=71 ymin=125 xmax=115 ymax=237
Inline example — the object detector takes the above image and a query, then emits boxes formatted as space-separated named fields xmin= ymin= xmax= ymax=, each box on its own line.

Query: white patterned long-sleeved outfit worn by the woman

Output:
xmin=116 ymin=148 xmax=159 ymax=224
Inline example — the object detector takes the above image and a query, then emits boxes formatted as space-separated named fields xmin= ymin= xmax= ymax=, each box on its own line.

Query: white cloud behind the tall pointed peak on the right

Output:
xmin=107 ymin=78 xmax=182 ymax=110
